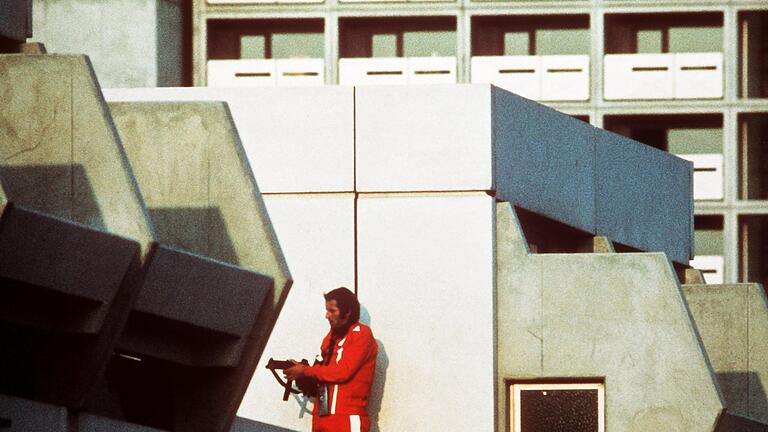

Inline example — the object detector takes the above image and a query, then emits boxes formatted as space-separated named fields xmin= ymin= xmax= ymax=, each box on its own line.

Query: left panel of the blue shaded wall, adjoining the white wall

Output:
xmin=491 ymin=87 xmax=599 ymax=233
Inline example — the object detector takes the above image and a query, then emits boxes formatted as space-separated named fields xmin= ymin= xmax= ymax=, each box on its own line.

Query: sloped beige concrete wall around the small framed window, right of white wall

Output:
xmin=496 ymin=203 xmax=724 ymax=432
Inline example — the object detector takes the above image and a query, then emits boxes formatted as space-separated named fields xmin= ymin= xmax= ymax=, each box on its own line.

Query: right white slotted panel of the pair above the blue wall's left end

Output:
xmin=541 ymin=55 xmax=589 ymax=101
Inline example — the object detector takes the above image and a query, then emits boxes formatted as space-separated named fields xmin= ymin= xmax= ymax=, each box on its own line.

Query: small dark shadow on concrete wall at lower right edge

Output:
xmin=716 ymin=371 xmax=768 ymax=420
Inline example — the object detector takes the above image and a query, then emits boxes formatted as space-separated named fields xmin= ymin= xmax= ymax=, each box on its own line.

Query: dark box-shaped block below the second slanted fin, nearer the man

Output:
xmin=119 ymin=246 xmax=273 ymax=367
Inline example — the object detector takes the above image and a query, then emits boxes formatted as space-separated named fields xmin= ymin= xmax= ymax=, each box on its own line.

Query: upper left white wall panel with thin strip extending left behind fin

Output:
xmin=104 ymin=86 xmax=355 ymax=193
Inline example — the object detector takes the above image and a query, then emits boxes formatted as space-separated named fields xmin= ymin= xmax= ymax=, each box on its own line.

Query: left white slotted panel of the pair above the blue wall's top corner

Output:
xmin=471 ymin=56 xmax=542 ymax=100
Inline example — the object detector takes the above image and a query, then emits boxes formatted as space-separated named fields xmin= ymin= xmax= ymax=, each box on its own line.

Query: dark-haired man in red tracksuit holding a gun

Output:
xmin=285 ymin=287 xmax=378 ymax=432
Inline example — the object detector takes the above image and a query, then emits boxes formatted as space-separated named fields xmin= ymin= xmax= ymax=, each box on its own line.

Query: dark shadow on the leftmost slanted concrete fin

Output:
xmin=0 ymin=164 xmax=105 ymax=230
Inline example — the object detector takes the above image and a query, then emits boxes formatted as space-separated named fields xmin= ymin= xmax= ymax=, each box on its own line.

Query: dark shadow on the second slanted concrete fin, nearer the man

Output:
xmin=149 ymin=207 xmax=240 ymax=265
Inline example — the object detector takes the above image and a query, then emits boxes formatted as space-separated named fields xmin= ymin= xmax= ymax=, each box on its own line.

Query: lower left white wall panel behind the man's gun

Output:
xmin=238 ymin=194 xmax=356 ymax=430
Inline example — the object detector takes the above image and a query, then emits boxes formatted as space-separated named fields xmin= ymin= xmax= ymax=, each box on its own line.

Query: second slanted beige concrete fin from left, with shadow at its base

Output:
xmin=110 ymin=98 xmax=291 ymax=330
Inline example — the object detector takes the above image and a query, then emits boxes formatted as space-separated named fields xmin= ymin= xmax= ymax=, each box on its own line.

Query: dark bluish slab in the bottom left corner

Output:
xmin=0 ymin=394 xmax=68 ymax=432
